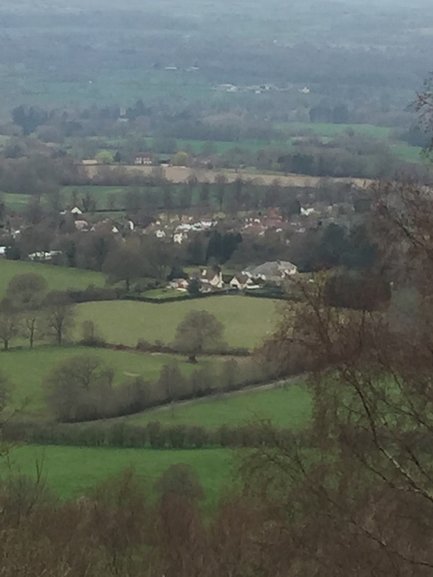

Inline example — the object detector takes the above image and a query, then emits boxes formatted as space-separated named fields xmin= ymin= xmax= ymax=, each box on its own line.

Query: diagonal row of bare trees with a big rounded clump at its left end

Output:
xmin=41 ymin=355 xmax=275 ymax=423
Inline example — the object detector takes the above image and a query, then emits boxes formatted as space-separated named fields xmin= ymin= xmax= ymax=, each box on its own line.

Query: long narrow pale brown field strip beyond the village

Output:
xmin=83 ymin=166 xmax=373 ymax=188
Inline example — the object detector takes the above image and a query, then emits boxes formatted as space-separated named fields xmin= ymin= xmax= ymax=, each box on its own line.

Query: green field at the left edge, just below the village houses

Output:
xmin=0 ymin=259 xmax=105 ymax=298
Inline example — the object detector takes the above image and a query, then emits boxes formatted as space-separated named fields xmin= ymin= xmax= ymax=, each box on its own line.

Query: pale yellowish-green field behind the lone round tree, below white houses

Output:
xmin=77 ymin=296 xmax=277 ymax=348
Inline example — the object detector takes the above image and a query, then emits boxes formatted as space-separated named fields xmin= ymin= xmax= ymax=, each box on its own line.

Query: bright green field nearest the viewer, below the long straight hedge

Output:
xmin=5 ymin=445 xmax=233 ymax=503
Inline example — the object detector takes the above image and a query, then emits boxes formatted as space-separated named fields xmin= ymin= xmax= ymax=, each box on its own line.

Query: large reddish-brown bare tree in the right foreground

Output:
xmin=241 ymin=179 xmax=433 ymax=577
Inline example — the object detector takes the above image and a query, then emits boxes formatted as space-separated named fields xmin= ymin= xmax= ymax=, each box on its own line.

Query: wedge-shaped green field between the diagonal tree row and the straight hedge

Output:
xmin=127 ymin=384 xmax=311 ymax=429
